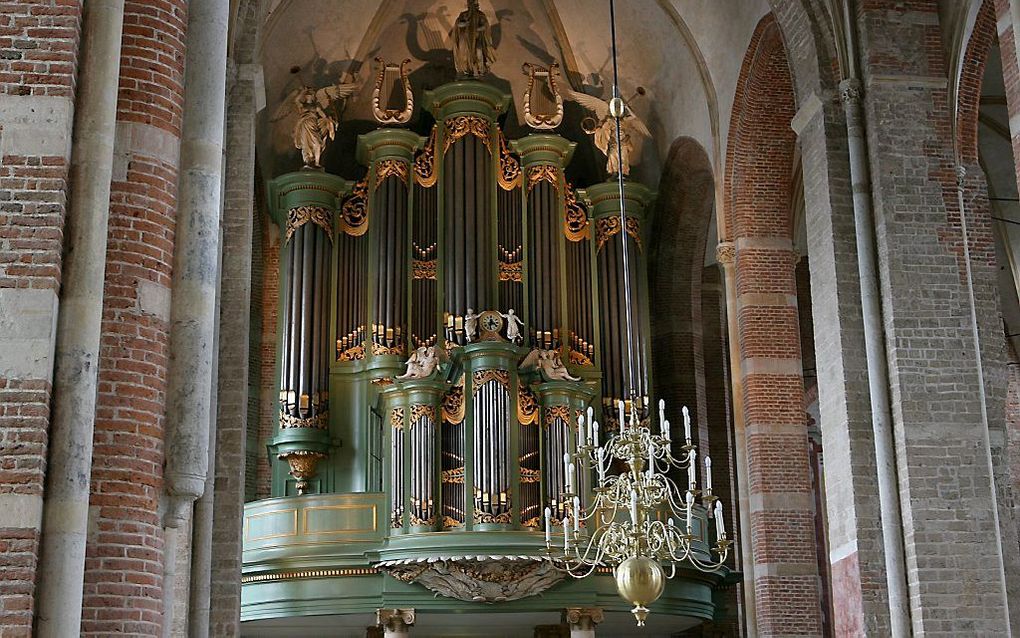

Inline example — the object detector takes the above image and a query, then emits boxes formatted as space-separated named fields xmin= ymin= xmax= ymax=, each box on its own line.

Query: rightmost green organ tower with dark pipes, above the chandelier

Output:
xmin=581 ymin=181 xmax=655 ymax=418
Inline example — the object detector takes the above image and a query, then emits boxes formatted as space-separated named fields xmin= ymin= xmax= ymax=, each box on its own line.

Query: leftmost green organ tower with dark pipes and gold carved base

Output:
xmin=269 ymin=170 xmax=349 ymax=494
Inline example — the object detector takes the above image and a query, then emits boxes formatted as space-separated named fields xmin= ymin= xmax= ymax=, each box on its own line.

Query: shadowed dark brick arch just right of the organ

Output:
xmin=649 ymin=137 xmax=715 ymax=449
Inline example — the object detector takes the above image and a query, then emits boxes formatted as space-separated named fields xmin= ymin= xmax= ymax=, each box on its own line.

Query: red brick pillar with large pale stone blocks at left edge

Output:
xmin=0 ymin=0 xmax=82 ymax=638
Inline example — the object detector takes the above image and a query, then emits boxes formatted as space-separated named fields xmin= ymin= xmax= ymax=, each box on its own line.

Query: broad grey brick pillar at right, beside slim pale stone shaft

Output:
xmin=857 ymin=1 xmax=1016 ymax=636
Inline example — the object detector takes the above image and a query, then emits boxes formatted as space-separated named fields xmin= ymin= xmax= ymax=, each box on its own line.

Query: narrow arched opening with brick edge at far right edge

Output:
xmin=948 ymin=0 xmax=1020 ymax=628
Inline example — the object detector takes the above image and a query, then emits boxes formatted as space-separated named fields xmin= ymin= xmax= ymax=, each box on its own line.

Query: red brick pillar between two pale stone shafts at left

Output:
xmin=82 ymin=0 xmax=187 ymax=636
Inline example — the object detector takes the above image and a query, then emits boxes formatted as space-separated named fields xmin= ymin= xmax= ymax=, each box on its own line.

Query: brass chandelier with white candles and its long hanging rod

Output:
xmin=545 ymin=0 xmax=732 ymax=627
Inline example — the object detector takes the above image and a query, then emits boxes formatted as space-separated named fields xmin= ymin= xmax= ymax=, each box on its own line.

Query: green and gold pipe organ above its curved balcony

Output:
xmin=269 ymin=81 xmax=653 ymax=539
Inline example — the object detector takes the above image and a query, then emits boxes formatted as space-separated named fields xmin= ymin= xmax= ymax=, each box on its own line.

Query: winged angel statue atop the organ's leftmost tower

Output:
xmin=272 ymin=78 xmax=357 ymax=168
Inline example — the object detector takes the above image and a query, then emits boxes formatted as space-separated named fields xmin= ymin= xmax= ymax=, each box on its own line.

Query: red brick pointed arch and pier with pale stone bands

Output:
xmin=724 ymin=14 xmax=822 ymax=636
